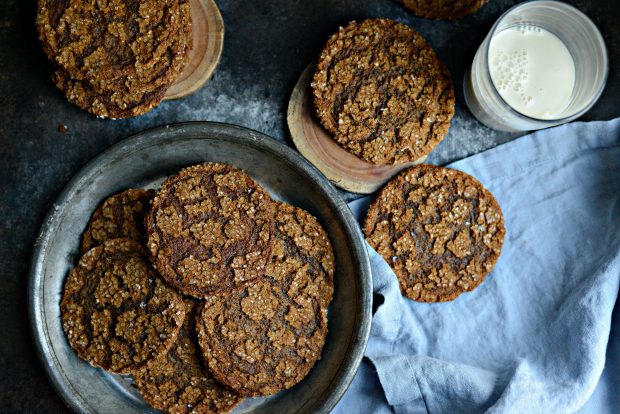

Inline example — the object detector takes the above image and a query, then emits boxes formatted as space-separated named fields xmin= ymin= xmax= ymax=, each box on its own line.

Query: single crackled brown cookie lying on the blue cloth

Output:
xmin=364 ymin=165 xmax=506 ymax=302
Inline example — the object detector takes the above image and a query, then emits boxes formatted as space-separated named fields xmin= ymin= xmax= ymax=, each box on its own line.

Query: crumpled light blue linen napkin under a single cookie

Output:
xmin=334 ymin=118 xmax=620 ymax=414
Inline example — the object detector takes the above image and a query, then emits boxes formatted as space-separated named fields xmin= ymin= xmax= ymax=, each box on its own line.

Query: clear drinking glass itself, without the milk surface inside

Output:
xmin=463 ymin=0 xmax=608 ymax=132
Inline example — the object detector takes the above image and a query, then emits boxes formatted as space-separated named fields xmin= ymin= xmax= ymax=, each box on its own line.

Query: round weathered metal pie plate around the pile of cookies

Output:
xmin=28 ymin=122 xmax=372 ymax=413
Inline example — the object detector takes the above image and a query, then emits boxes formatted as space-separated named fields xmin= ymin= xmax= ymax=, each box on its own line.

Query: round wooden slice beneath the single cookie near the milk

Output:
xmin=286 ymin=63 xmax=426 ymax=194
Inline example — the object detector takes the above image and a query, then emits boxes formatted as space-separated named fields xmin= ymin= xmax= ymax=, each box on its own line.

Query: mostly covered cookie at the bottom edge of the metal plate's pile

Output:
xmin=133 ymin=299 xmax=241 ymax=414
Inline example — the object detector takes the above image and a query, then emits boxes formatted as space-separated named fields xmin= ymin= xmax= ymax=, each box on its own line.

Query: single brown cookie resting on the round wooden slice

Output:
xmin=312 ymin=19 xmax=454 ymax=164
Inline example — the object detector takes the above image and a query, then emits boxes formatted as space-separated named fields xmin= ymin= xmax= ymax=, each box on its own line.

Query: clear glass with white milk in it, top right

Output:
xmin=463 ymin=0 xmax=608 ymax=132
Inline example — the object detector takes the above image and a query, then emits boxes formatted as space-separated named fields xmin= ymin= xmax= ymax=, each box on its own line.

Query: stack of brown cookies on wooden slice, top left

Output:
xmin=36 ymin=0 xmax=192 ymax=118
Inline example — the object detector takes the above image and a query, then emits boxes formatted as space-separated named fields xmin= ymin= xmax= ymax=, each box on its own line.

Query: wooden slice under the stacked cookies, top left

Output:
xmin=164 ymin=0 xmax=224 ymax=100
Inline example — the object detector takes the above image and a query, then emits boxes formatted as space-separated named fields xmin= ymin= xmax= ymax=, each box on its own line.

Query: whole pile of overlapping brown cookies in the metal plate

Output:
xmin=61 ymin=164 xmax=334 ymax=413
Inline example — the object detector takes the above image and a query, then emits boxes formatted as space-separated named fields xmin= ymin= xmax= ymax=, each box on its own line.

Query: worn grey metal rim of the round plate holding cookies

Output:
xmin=28 ymin=122 xmax=372 ymax=413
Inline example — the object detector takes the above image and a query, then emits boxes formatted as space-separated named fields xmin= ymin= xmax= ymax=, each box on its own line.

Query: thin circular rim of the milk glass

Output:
xmin=484 ymin=0 xmax=609 ymax=126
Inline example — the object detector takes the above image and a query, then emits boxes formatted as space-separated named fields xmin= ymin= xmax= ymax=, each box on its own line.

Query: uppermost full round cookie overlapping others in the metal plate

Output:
xmin=146 ymin=163 xmax=274 ymax=298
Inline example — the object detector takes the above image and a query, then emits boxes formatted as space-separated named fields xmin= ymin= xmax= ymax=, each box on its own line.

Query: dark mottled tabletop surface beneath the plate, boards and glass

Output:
xmin=0 ymin=0 xmax=620 ymax=413
